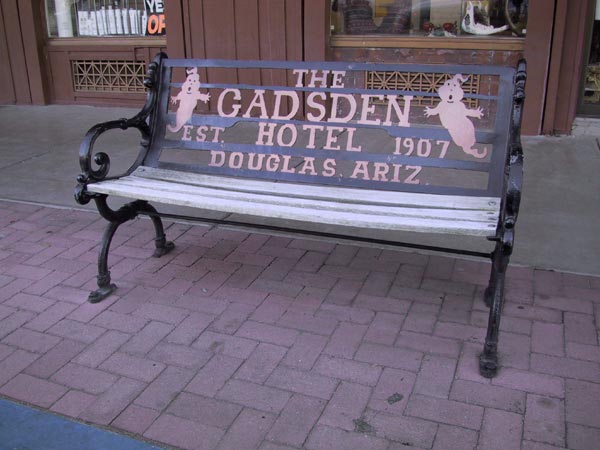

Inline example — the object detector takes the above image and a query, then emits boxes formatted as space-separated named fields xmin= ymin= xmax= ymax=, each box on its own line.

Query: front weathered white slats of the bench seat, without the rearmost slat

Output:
xmin=88 ymin=176 xmax=497 ymax=236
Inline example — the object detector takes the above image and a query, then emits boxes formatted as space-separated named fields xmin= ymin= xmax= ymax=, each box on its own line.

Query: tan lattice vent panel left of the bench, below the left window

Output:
xmin=71 ymin=60 xmax=146 ymax=92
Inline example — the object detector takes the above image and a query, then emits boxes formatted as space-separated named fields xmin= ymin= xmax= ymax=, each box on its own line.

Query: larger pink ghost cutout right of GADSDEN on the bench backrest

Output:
xmin=425 ymin=74 xmax=488 ymax=158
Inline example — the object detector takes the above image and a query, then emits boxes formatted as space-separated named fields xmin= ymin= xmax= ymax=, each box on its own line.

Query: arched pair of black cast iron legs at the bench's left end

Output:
xmin=88 ymin=196 xmax=175 ymax=303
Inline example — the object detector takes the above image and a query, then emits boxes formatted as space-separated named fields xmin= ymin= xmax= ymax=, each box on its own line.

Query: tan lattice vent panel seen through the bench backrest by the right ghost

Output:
xmin=366 ymin=71 xmax=480 ymax=108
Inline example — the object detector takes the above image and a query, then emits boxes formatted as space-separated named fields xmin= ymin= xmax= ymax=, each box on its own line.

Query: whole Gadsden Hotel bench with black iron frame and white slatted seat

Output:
xmin=75 ymin=53 xmax=526 ymax=377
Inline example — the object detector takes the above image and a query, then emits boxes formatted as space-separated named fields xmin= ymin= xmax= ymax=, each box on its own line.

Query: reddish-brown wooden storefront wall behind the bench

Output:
xmin=0 ymin=0 xmax=600 ymax=134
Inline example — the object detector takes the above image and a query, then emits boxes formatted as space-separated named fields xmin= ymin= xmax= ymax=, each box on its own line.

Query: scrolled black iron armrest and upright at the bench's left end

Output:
xmin=75 ymin=53 xmax=166 ymax=205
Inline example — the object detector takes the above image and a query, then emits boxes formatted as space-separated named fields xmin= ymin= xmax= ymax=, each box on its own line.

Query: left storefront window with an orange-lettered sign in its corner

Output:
xmin=46 ymin=0 xmax=166 ymax=37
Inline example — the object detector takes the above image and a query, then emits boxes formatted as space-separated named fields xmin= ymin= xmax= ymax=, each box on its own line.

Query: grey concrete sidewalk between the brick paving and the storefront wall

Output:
xmin=0 ymin=106 xmax=600 ymax=275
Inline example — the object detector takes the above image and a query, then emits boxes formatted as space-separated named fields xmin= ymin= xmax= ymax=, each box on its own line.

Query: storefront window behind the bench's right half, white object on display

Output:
xmin=331 ymin=0 xmax=528 ymax=37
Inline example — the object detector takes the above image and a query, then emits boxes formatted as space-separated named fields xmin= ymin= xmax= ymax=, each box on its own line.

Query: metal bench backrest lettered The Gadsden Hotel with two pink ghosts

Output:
xmin=144 ymin=58 xmax=519 ymax=197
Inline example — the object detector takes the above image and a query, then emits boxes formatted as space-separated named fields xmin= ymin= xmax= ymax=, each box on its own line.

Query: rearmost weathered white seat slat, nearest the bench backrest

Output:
xmin=132 ymin=166 xmax=500 ymax=211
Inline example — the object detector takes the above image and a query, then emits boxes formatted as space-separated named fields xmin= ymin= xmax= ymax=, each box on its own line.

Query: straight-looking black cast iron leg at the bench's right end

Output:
xmin=479 ymin=242 xmax=510 ymax=378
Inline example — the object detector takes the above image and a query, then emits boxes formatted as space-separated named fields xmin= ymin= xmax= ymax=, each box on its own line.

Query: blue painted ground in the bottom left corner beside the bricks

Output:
xmin=0 ymin=399 xmax=162 ymax=450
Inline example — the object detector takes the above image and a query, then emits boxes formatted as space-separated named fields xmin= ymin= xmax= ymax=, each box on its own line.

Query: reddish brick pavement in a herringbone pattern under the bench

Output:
xmin=0 ymin=201 xmax=600 ymax=450
